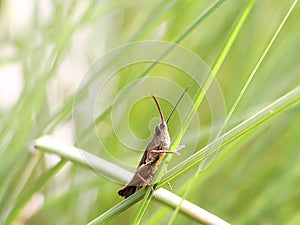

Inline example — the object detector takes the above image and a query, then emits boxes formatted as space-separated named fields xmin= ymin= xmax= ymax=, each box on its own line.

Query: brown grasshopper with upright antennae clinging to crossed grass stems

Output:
xmin=118 ymin=86 xmax=190 ymax=198
